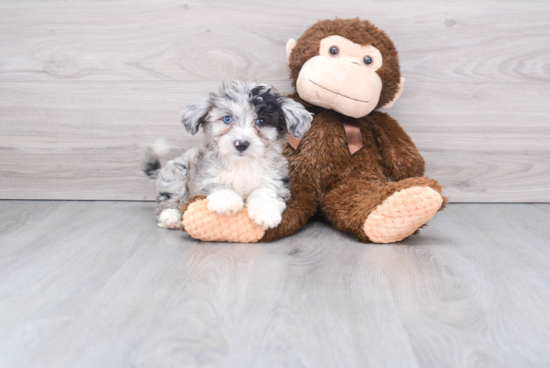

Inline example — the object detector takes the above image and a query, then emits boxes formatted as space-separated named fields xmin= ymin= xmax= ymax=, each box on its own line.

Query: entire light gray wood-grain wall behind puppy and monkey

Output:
xmin=0 ymin=0 xmax=550 ymax=202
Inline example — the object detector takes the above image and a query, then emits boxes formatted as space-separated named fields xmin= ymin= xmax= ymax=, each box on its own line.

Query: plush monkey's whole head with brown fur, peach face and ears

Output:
xmin=286 ymin=18 xmax=405 ymax=118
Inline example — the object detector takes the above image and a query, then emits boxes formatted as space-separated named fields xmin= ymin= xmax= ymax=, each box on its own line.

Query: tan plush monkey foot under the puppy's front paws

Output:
xmin=183 ymin=199 xmax=265 ymax=243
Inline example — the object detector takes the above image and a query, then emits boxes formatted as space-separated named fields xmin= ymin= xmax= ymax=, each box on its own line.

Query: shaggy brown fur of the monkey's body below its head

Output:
xmin=262 ymin=95 xmax=446 ymax=242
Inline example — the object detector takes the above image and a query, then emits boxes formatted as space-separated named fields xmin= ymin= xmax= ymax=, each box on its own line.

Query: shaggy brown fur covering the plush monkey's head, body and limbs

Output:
xmin=183 ymin=19 xmax=446 ymax=242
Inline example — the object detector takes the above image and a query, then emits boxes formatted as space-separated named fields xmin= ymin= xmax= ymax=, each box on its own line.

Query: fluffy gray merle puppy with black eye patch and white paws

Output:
xmin=143 ymin=81 xmax=313 ymax=230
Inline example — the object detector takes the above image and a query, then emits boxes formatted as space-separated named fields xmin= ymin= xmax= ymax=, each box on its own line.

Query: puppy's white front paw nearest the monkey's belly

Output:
xmin=246 ymin=188 xmax=286 ymax=230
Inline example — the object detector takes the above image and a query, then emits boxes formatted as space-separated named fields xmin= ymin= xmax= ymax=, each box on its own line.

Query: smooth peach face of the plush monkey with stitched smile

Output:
xmin=296 ymin=35 xmax=383 ymax=118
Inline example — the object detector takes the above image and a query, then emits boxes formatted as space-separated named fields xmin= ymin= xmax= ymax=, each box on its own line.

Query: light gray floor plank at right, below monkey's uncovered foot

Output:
xmin=381 ymin=204 xmax=550 ymax=367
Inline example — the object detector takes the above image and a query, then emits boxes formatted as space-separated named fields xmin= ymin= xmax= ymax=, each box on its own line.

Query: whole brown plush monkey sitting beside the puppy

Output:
xmin=181 ymin=19 xmax=447 ymax=243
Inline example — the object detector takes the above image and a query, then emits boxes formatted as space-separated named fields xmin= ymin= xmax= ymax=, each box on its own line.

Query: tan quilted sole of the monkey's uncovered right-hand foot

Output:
xmin=363 ymin=187 xmax=443 ymax=243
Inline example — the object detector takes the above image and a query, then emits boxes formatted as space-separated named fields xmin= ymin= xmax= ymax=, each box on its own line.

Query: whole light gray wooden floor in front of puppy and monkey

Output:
xmin=0 ymin=201 xmax=550 ymax=368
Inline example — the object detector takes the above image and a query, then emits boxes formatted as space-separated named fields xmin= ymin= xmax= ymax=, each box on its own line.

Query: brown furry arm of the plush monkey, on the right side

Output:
xmin=369 ymin=112 xmax=424 ymax=181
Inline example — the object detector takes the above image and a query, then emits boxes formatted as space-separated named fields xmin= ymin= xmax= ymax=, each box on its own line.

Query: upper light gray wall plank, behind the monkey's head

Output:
xmin=0 ymin=0 xmax=550 ymax=83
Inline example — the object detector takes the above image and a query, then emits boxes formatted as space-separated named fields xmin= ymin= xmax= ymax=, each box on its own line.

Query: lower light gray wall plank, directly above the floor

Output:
xmin=0 ymin=81 xmax=550 ymax=202
